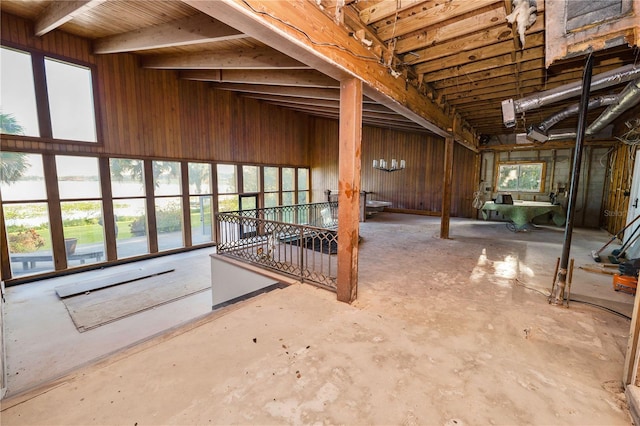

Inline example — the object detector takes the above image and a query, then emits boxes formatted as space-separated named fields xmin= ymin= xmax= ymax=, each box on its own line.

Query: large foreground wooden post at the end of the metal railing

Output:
xmin=337 ymin=78 xmax=362 ymax=303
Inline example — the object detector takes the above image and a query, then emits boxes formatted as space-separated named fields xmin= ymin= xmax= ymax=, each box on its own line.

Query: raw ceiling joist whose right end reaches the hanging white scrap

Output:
xmin=396 ymin=7 xmax=506 ymax=54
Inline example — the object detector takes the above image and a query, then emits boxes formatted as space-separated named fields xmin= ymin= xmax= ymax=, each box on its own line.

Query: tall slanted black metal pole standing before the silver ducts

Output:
xmin=551 ymin=54 xmax=593 ymax=305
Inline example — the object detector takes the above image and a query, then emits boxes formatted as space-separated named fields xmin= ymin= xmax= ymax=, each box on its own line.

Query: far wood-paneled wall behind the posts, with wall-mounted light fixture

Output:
xmin=309 ymin=118 xmax=479 ymax=217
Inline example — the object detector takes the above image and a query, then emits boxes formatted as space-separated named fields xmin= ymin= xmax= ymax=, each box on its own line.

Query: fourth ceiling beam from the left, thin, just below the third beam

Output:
xmin=179 ymin=69 xmax=340 ymax=89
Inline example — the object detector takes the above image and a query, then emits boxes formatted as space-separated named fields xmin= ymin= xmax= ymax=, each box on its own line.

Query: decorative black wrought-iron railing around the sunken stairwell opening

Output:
xmin=216 ymin=202 xmax=338 ymax=291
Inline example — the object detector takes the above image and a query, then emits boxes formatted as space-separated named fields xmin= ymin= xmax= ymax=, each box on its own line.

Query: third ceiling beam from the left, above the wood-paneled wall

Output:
xmin=142 ymin=48 xmax=309 ymax=70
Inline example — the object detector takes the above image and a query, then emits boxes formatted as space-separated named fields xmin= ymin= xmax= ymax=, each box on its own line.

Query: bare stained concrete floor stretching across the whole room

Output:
xmin=2 ymin=213 xmax=633 ymax=425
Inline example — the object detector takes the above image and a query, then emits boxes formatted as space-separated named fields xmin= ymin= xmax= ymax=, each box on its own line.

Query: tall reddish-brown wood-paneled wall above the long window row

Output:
xmin=0 ymin=14 xmax=308 ymax=166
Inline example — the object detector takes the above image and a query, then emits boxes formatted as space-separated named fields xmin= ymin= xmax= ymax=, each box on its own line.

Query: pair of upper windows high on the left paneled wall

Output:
xmin=0 ymin=47 xmax=98 ymax=142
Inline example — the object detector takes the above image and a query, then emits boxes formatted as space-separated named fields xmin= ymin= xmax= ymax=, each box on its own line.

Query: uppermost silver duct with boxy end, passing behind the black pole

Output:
xmin=502 ymin=64 xmax=640 ymax=127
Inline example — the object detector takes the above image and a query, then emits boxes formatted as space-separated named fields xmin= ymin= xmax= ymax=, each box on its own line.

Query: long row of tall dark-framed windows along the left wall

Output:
xmin=0 ymin=155 xmax=310 ymax=280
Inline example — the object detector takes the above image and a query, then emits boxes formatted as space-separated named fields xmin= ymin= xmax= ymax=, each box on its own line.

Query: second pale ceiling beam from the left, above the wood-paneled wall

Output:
xmin=93 ymin=14 xmax=247 ymax=54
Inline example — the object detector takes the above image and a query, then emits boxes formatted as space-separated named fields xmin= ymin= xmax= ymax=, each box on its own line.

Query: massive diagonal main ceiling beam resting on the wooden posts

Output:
xmin=181 ymin=0 xmax=477 ymax=151
